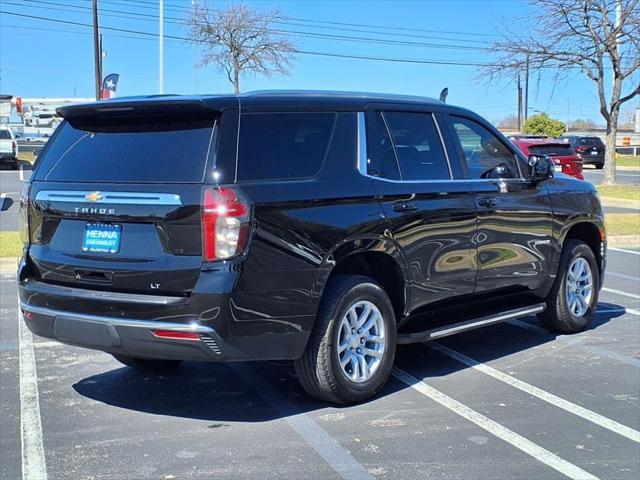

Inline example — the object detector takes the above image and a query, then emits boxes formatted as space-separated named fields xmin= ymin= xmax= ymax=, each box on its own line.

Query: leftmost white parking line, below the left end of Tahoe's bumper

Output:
xmin=18 ymin=308 xmax=47 ymax=480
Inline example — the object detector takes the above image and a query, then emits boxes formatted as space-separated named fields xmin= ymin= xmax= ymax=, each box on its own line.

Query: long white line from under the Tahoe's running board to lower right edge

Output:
xmin=425 ymin=342 xmax=640 ymax=443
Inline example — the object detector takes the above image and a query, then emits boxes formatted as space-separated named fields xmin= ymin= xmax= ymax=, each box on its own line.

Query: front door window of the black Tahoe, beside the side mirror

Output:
xmin=451 ymin=116 xmax=520 ymax=179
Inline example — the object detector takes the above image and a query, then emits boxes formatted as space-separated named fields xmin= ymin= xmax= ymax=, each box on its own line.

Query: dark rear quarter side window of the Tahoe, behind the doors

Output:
xmin=238 ymin=112 xmax=337 ymax=181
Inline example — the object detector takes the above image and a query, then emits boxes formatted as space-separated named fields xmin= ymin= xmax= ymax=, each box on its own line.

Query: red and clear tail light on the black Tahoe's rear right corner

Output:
xmin=202 ymin=187 xmax=251 ymax=262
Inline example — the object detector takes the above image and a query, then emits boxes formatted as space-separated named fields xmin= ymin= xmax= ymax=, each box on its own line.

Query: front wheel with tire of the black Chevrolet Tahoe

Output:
xmin=538 ymin=239 xmax=600 ymax=333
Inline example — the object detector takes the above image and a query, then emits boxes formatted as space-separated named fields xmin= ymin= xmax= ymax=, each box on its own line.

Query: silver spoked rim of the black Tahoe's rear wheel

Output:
xmin=337 ymin=300 xmax=386 ymax=383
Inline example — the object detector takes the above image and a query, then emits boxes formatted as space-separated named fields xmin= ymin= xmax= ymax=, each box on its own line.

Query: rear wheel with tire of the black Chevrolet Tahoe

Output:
xmin=294 ymin=275 xmax=396 ymax=404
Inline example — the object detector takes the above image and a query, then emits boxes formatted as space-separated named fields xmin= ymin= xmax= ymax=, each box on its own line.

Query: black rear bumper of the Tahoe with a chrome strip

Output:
xmin=18 ymin=262 xmax=315 ymax=361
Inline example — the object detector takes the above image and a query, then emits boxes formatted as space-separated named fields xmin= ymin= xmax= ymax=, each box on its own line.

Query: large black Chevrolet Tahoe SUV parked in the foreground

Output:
xmin=18 ymin=92 xmax=606 ymax=403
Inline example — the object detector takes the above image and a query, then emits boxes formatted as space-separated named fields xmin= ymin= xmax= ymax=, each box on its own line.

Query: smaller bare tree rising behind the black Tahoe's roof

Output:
xmin=187 ymin=3 xmax=295 ymax=94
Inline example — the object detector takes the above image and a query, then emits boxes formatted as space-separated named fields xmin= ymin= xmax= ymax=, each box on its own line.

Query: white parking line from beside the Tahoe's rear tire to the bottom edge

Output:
xmin=393 ymin=367 xmax=598 ymax=480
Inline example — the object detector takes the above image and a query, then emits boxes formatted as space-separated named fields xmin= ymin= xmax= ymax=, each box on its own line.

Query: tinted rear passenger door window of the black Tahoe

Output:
xmin=384 ymin=112 xmax=451 ymax=180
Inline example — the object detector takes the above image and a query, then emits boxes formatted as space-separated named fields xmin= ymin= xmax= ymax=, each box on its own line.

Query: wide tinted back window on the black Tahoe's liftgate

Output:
xmin=35 ymin=119 xmax=214 ymax=183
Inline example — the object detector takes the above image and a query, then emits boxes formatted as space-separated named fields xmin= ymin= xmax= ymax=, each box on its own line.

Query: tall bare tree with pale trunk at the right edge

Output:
xmin=485 ymin=0 xmax=640 ymax=183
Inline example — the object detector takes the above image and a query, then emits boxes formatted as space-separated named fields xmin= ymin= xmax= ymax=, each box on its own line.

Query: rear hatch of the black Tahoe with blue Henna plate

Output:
xmin=29 ymin=103 xmax=216 ymax=295
